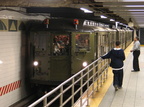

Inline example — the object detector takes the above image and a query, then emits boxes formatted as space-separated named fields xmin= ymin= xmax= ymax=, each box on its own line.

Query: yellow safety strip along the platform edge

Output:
xmin=89 ymin=43 xmax=133 ymax=107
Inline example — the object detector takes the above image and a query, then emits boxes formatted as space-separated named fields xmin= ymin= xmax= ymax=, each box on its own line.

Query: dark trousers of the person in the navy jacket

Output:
xmin=113 ymin=69 xmax=123 ymax=87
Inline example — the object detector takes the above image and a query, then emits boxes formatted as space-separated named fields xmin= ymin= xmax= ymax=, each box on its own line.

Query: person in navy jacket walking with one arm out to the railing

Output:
xmin=101 ymin=41 xmax=125 ymax=91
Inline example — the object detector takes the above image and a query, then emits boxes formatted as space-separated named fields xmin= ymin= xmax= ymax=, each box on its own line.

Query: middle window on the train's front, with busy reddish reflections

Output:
xmin=53 ymin=35 xmax=70 ymax=56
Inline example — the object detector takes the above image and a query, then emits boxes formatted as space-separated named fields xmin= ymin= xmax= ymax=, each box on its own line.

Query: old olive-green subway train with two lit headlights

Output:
xmin=27 ymin=18 xmax=133 ymax=85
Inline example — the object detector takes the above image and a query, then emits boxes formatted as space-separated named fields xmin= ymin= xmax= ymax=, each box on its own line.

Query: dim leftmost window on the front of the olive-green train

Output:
xmin=34 ymin=33 xmax=47 ymax=51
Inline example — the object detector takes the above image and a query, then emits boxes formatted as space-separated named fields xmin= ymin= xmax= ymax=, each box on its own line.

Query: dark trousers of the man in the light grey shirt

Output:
xmin=133 ymin=51 xmax=140 ymax=71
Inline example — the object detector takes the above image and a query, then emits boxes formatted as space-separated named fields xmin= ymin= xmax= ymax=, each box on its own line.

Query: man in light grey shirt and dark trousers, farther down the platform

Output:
xmin=131 ymin=37 xmax=140 ymax=72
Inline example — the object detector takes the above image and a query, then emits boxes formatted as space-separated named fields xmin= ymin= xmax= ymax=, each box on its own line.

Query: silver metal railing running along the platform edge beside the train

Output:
xmin=28 ymin=58 xmax=109 ymax=107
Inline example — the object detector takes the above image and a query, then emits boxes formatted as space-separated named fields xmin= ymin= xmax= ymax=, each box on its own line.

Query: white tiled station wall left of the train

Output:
xmin=0 ymin=7 xmax=45 ymax=107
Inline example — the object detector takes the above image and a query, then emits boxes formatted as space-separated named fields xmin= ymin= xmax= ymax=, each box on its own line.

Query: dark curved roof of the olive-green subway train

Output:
xmin=26 ymin=19 xmax=114 ymax=32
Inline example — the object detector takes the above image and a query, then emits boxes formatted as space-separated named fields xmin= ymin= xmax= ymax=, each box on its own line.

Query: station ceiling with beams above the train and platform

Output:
xmin=0 ymin=0 xmax=144 ymax=28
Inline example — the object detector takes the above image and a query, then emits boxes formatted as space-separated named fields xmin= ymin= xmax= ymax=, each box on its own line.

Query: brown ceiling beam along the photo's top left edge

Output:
xmin=0 ymin=0 xmax=73 ymax=7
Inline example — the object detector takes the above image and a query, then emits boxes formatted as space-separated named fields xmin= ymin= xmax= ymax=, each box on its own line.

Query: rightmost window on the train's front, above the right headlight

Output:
xmin=75 ymin=34 xmax=89 ymax=52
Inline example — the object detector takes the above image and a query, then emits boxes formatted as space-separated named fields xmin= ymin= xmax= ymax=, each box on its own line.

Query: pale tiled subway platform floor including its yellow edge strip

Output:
xmin=89 ymin=43 xmax=144 ymax=107
